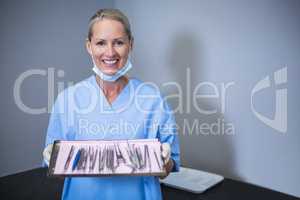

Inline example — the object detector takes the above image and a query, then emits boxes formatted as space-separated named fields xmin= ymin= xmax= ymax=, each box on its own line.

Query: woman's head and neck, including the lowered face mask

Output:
xmin=86 ymin=9 xmax=133 ymax=103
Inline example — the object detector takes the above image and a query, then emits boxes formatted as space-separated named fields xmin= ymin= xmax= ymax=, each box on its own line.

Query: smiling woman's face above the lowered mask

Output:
xmin=86 ymin=19 xmax=132 ymax=75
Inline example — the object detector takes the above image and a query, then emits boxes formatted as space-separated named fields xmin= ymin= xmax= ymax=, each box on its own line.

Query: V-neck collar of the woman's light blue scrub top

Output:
xmin=92 ymin=75 xmax=131 ymax=111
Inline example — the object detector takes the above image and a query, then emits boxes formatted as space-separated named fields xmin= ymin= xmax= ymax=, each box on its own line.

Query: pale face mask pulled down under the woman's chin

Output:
xmin=92 ymin=56 xmax=132 ymax=82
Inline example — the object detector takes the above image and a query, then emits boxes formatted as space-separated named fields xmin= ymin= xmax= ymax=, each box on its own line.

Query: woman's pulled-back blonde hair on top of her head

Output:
xmin=88 ymin=9 xmax=133 ymax=41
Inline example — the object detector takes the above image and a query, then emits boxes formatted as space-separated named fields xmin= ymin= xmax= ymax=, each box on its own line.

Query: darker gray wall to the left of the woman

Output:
xmin=0 ymin=0 xmax=113 ymax=172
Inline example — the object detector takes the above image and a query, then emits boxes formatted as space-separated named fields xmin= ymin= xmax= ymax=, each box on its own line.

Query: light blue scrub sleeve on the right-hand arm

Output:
xmin=158 ymin=102 xmax=180 ymax=172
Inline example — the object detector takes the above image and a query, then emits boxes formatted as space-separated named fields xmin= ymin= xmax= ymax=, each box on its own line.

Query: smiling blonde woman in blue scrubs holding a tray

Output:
xmin=43 ymin=9 xmax=179 ymax=200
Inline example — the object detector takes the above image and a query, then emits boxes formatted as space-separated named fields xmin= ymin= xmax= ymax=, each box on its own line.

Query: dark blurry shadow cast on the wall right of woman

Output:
xmin=163 ymin=32 xmax=240 ymax=179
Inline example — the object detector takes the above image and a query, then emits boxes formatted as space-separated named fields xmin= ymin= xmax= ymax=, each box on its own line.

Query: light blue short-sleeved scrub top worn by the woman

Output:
xmin=46 ymin=75 xmax=180 ymax=200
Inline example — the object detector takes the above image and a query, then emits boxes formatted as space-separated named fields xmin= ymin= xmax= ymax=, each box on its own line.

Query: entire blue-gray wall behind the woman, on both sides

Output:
xmin=0 ymin=0 xmax=300 ymax=197
